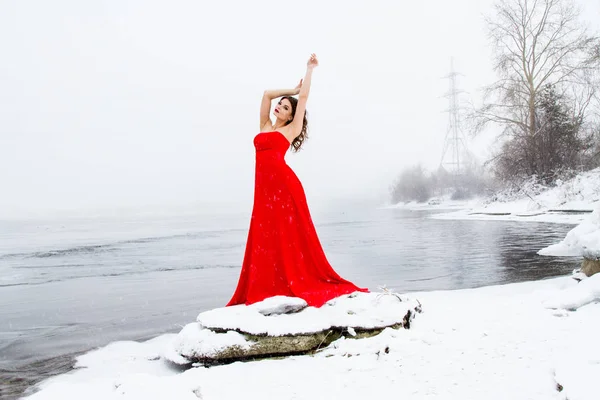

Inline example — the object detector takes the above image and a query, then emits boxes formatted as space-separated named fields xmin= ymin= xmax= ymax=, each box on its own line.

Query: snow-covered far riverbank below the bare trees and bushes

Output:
xmin=388 ymin=168 xmax=600 ymax=224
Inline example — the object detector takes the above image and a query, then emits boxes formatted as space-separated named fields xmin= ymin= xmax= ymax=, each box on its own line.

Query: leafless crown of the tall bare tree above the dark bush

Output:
xmin=474 ymin=0 xmax=599 ymax=136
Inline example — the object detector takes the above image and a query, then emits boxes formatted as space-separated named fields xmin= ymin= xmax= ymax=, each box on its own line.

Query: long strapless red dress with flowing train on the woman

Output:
xmin=227 ymin=131 xmax=367 ymax=307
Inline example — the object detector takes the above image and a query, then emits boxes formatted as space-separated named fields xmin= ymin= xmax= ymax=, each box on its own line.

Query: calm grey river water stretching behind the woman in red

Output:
xmin=0 ymin=209 xmax=579 ymax=399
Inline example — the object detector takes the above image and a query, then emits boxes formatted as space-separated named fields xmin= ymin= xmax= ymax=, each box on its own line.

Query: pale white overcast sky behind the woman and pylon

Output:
xmin=0 ymin=0 xmax=600 ymax=216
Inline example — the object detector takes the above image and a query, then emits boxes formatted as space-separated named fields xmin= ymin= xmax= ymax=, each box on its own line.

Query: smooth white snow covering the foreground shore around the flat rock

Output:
xmin=29 ymin=274 xmax=600 ymax=400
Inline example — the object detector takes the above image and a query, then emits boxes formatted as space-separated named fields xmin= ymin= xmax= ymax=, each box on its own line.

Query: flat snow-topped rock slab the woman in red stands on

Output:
xmin=164 ymin=292 xmax=421 ymax=365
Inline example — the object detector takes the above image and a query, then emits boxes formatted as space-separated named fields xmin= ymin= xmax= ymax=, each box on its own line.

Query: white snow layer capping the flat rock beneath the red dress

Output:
xmin=196 ymin=292 xmax=419 ymax=336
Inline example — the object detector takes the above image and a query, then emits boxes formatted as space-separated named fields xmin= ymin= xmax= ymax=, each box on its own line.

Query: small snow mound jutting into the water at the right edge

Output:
xmin=538 ymin=206 xmax=600 ymax=259
